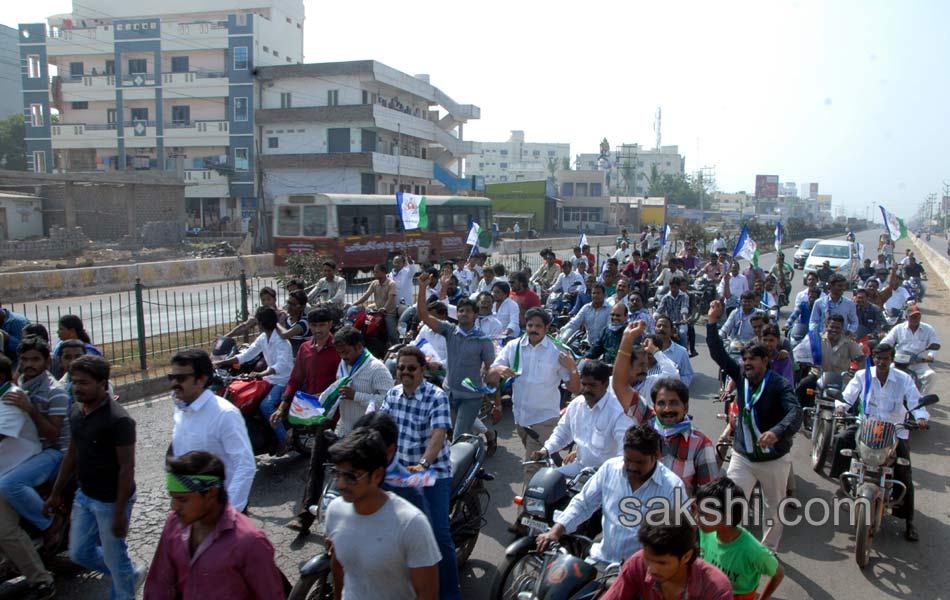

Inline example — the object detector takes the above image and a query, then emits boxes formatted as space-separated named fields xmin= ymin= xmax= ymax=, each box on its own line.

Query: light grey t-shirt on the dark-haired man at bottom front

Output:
xmin=326 ymin=492 xmax=442 ymax=600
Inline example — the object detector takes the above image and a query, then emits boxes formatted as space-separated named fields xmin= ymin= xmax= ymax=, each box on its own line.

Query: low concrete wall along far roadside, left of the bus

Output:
xmin=0 ymin=254 xmax=274 ymax=302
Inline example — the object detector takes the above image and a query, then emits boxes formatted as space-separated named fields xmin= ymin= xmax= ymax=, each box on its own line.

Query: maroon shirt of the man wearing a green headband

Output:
xmin=144 ymin=503 xmax=286 ymax=600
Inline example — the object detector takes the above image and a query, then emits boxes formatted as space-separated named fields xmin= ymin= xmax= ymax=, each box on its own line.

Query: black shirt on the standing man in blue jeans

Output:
xmin=69 ymin=398 xmax=135 ymax=502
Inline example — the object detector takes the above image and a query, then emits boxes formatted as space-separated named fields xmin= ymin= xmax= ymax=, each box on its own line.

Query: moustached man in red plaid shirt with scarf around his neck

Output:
xmin=650 ymin=377 xmax=719 ymax=494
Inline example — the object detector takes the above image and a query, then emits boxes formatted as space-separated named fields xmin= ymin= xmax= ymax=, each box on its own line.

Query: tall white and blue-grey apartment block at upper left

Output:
xmin=18 ymin=0 xmax=304 ymax=229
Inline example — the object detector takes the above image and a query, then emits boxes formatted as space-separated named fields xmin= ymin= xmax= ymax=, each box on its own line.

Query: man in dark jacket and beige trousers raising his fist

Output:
xmin=706 ymin=300 xmax=802 ymax=550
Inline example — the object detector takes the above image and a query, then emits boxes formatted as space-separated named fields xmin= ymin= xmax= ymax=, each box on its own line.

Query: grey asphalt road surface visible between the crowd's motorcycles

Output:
xmin=0 ymin=231 xmax=950 ymax=600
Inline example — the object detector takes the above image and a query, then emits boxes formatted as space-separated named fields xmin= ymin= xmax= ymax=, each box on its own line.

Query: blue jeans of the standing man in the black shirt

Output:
xmin=69 ymin=490 xmax=136 ymax=600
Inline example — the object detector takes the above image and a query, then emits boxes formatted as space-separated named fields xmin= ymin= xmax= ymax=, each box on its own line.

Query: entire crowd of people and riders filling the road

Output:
xmin=0 ymin=229 xmax=940 ymax=600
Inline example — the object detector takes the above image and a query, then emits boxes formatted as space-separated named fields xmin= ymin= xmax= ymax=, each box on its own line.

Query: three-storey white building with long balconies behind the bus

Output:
xmin=256 ymin=60 xmax=481 ymax=198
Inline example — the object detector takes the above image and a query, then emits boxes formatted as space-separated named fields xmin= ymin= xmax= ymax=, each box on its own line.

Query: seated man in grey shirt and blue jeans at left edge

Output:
xmin=0 ymin=336 xmax=70 ymax=548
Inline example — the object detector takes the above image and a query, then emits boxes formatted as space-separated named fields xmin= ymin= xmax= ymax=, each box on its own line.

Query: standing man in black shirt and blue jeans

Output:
xmin=43 ymin=355 xmax=144 ymax=600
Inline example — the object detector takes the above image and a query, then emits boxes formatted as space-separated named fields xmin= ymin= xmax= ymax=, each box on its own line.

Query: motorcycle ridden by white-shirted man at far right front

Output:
xmin=839 ymin=394 xmax=939 ymax=569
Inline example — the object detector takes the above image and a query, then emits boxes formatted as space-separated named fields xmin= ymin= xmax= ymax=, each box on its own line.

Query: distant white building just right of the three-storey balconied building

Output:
xmin=465 ymin=131 xmax=571 ymax=183
